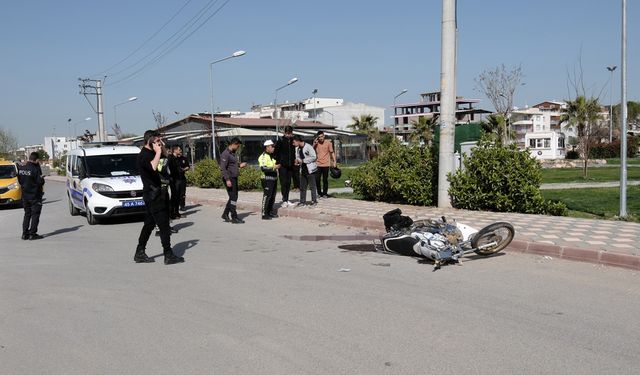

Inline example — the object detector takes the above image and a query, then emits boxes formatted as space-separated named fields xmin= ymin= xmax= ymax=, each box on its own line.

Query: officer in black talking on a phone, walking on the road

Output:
xmin=133 ymin=130 xmax=184 ymax=264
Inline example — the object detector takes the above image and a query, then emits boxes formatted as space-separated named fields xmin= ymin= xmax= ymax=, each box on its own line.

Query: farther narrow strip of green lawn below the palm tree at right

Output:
xmin=542 ymin=167 xmax=640 ymax=183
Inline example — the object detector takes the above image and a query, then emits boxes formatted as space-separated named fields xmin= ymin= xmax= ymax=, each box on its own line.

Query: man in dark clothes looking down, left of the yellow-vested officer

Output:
xmin=220 ymin=138 xmax=247 ymax=224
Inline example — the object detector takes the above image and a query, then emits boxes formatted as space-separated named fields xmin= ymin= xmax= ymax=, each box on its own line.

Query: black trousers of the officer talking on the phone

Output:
xmin=136 ymin=188 xmax=173 ymax=257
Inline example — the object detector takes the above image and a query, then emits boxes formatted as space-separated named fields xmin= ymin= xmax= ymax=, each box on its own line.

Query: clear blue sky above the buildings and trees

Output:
xmin=0 ymin=0 xmax=640 ymax=145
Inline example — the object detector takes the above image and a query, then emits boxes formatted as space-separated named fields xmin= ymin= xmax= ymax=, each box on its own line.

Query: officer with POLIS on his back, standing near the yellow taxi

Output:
xmin=18 ymin=152 xmax=44 ymax=240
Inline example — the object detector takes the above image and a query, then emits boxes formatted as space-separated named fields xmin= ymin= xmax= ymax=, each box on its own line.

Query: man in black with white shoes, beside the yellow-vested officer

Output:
xmin=274 ymin=126 xmax=300 ymax=207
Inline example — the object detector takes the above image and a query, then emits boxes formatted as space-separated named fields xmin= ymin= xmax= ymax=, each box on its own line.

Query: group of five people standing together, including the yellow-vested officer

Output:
xmin=220 ymin=126 xmax=337 ymax=224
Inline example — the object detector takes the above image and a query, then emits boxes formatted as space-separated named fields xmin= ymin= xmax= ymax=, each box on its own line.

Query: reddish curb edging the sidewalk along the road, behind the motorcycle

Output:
xmin=190 ymin=199 xmax=640 ymax=270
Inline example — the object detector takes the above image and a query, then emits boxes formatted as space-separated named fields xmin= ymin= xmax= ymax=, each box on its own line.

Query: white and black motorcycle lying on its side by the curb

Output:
xmin=381 ymin=209 xmax=515 ymax=270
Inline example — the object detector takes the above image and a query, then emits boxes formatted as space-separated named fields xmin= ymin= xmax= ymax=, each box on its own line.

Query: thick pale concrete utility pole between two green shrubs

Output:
xmin=438 ymin=0 xmax=456 ymax=208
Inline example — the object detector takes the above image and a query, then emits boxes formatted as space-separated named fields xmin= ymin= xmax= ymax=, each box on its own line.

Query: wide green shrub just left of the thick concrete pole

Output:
xmin=351 ymin=142 xmax=435 ymax=206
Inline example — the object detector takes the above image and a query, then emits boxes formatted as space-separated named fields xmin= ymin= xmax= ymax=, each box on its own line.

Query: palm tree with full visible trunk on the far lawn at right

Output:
xmin=561 ymin=95 xmax=602 ymax=178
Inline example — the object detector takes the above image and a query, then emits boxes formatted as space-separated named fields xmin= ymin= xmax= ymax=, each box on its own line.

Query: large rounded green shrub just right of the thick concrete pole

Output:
xmin=448 ymin=138 xmax=567 ymax=215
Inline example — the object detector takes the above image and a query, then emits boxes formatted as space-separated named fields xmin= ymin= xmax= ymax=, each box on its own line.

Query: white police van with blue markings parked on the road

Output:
xmin=66 ymin=143 xmax=145 ymax=225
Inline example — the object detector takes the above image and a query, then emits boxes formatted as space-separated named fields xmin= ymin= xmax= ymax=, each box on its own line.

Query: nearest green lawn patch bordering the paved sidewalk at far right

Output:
xmin=542 ymin=186 xmax=640 ymax=221
